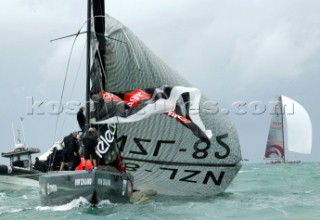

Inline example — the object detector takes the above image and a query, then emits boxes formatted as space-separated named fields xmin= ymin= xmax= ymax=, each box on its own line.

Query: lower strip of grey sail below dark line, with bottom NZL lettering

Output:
xmin=122 ymin=161 xmax=241 ymax=196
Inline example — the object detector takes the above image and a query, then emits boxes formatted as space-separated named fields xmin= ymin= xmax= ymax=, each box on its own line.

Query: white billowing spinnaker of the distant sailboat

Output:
xmin=281 ymin=96 xmax=312 ymax=154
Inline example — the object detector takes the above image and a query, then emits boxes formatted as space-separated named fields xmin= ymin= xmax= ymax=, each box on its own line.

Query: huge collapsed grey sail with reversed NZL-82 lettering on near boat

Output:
xmin=87 ymin=1 xmax=241 ymax=196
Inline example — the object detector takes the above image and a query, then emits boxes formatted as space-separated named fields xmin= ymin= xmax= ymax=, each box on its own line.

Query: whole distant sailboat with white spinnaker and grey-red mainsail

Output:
xmin=264 ymin=95 xmax=312 ymax=163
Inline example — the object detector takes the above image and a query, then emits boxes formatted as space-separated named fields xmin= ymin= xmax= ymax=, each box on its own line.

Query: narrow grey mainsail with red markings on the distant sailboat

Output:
xmin=264 ymin=96 xmax=285 ymax=161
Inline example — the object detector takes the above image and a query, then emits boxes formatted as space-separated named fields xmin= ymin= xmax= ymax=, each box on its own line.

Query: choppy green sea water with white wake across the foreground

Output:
xmin=0 ymin=163 xmax=320 ymax=220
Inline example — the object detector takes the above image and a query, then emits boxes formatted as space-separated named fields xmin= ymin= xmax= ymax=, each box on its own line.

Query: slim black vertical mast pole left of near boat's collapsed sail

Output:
xmin=84 ymin=0 xmax=91 ymax=132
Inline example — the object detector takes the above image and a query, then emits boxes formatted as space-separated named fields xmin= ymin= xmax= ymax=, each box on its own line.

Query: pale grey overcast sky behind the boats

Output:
xmin=0 ymin=0 xmax=320 ymax=163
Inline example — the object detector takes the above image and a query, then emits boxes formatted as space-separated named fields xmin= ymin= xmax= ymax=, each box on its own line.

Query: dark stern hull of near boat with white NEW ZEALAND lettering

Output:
xmin=39 ymin=169 xmax=132 ymax=206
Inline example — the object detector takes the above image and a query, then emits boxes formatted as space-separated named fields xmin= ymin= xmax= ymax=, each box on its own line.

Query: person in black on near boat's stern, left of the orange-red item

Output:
xmin=60 ymin=131 xmax=81 ymax=171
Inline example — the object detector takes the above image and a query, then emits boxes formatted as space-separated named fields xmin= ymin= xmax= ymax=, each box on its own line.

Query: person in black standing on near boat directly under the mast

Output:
xmin=82 ymin=128 xmax=98 ymax=169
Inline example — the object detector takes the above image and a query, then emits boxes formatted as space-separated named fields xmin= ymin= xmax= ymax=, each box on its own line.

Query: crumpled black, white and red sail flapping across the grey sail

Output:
xmin=91 ymin=86 xmax=212 ymax=139
